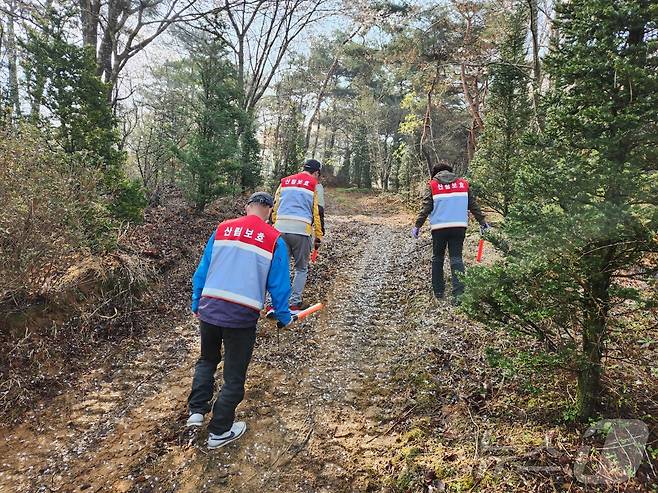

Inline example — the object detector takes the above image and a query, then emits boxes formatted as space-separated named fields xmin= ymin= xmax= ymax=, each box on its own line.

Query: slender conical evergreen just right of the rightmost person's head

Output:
xmin=469 ymin=3 xmax=531 ymax=216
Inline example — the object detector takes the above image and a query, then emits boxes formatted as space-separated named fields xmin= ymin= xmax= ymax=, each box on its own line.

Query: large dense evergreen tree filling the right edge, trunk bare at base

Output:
xmin=464 ymin=0 xmax=658 ymax=419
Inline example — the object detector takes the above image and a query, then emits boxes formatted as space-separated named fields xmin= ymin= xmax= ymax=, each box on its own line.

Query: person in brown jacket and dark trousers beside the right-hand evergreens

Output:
xmin=411 ymin=163 xmax=489 ymax=302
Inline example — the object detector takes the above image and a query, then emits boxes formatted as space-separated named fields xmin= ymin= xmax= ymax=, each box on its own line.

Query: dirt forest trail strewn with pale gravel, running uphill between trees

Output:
xmin=0 ymin=192 xmax=472 ymax=492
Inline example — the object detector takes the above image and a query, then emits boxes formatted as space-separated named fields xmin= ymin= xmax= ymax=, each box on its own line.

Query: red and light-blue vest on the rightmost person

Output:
xmin=429 ymin=178 xmax=468 ymax=230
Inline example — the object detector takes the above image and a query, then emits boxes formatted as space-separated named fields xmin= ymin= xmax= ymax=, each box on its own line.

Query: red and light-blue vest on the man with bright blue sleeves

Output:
xmin=201 ymin=216 xmax=279 ymax=310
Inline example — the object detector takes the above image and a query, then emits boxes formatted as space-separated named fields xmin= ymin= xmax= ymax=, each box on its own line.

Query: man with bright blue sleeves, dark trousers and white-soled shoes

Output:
xmin=187 ymin=192 xmax=292 ymax=449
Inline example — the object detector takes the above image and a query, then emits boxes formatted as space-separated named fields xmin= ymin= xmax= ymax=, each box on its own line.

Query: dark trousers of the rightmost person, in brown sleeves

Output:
xmin=432 ymin=228 xmax=466 ymax=298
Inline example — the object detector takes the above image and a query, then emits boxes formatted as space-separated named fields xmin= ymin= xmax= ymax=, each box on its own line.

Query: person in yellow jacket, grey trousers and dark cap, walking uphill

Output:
xmin=267 ymin=159 xmax=324 ymax=317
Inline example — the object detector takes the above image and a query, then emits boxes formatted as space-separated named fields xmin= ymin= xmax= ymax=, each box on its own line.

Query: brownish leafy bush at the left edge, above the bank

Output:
xmin=0 ymin=127 xmax=115 ymax=299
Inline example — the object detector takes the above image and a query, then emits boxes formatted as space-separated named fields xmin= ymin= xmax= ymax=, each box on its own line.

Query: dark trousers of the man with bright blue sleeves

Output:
xmin=187 ymin=321 xmax=256 ymax=434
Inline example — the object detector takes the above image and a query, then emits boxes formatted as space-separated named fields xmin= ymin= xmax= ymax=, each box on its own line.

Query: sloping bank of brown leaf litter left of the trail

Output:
xmin=0 ymin=190 xmax=240 ymax=423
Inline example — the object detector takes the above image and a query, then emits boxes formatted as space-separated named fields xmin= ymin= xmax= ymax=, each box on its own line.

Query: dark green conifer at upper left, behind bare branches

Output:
xmin=23 ymin=8 xmax=146 ymax=221
